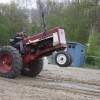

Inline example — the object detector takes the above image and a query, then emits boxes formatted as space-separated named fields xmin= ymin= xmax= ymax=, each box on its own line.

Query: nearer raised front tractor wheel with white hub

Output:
xmin=55 ymin=51 xmax=70 ymax=67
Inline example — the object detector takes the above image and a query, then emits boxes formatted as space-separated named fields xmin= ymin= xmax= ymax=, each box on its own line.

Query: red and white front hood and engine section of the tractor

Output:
xmin=23 ymin=27 xmax=67 ymax=56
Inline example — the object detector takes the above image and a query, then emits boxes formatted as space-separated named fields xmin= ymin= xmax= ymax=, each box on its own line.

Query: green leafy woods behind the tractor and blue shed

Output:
xmin=0 ymin=0 xmax=100 ymax=56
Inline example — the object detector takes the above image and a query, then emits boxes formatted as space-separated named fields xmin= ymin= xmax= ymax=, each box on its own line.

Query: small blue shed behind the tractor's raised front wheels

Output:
xmin=67 ymin=42 xmax=86 ymax=66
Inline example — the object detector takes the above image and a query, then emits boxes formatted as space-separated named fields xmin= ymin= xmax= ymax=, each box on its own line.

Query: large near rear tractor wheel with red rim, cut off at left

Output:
xmin=0 ymin=46 xmax=22 ymax=78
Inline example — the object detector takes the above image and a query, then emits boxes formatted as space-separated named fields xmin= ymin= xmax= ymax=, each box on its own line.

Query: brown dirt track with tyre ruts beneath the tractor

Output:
xmin=0 ymin=65 xmax=100 ymax=100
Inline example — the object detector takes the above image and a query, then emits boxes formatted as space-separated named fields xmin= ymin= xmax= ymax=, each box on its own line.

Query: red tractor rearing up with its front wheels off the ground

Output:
xmin=0 ymin=1 xmax=72 ymax=78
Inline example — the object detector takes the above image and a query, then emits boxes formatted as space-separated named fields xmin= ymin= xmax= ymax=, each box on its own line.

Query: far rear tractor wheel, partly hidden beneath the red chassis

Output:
xmin=21 ymin=58 xmax=43 ymax=77
